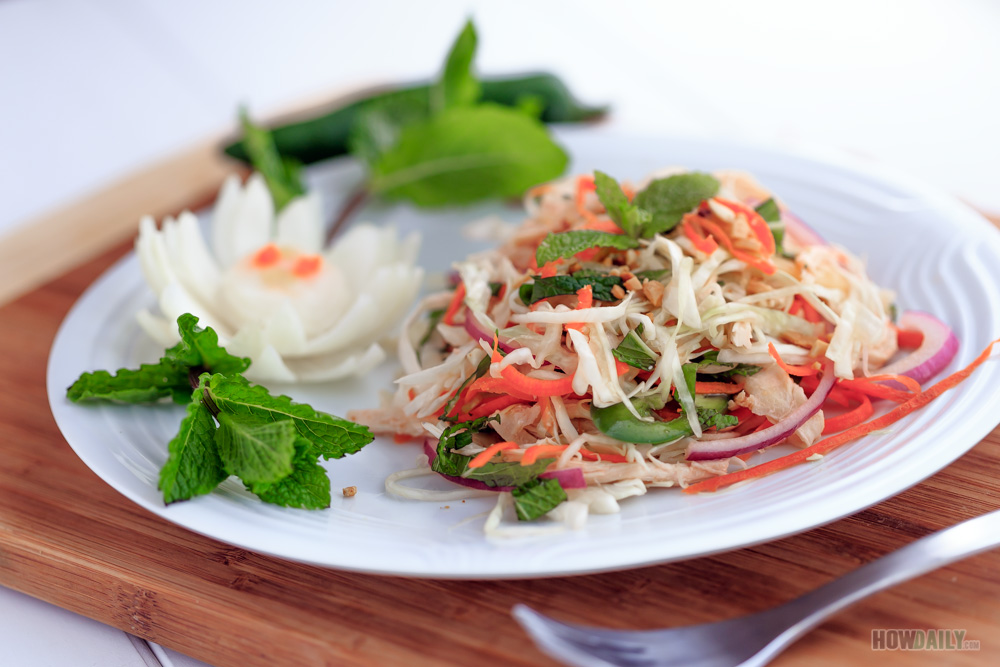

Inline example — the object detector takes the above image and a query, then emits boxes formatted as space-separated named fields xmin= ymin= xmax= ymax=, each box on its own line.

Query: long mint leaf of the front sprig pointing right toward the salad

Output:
xmin=205 ymin=374 xmax=374 ymax=459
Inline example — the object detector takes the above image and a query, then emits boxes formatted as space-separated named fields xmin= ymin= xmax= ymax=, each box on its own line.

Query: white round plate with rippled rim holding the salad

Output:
xmin=48 ymin=131 xmax=1000 ymax=579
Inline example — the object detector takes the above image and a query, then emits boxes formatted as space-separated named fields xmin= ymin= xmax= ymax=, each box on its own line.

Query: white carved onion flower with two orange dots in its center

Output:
xmin=135 ymin=174 xmax=423 ymax=382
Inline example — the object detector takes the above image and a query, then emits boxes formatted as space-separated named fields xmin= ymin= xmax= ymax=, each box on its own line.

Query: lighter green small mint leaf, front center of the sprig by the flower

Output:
xmin=215 ymin=412 xmax=296 ymax=484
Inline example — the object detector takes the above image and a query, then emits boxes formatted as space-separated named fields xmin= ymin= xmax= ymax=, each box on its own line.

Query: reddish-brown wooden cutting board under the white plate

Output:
xmin=0 ymin=151 xmax=1000 ymax=667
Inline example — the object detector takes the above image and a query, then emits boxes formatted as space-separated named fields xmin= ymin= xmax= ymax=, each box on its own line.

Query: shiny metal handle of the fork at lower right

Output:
xmin=750 ymin=510 xmax=1000 ymax=664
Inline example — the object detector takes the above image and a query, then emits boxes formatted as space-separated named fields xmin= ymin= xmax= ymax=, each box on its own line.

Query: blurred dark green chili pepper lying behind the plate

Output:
xmin=225 ymin=73 xmax=607 ymax=164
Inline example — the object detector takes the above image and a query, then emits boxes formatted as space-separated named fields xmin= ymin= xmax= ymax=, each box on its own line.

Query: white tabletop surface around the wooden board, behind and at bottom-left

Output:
xmin=0 ymin=0 xmax=1000 ymax=667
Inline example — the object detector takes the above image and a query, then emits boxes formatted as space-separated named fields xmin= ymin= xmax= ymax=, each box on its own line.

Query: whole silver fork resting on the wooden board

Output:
xmin=512 ymin=510 xmax=1000 ymax=667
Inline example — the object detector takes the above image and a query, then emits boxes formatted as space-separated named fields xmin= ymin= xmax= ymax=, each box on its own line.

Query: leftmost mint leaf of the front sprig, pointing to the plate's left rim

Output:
xmin=66 ymin=360 xmax=191 ymax=403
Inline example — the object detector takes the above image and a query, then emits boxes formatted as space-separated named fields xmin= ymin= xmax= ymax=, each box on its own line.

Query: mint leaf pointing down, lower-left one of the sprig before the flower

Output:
xmin=158 ymin=387 xmax=227 ymax=504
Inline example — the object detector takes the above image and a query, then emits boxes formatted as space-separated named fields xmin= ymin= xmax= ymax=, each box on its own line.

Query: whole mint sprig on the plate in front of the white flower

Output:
xmin=67 ymin=314 xmax=373 ymax=509
